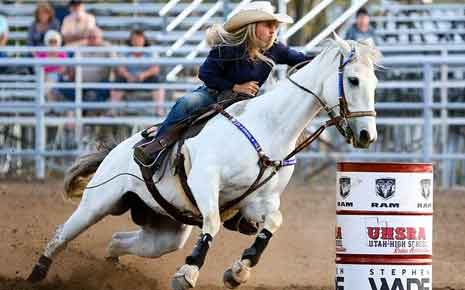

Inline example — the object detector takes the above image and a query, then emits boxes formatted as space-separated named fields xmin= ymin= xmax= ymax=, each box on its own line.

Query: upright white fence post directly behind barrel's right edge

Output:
xmin=423 ymin=63 xmax=433 ymax=162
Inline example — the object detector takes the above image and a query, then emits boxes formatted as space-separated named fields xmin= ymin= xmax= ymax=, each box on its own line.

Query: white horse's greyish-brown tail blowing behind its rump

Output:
xmin=64 ymin=141 xmax=117 ymax=199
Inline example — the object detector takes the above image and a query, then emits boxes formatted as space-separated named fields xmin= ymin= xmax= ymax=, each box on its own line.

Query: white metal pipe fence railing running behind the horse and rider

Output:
xmin=0 ymin=47 xmax=465 ymax=187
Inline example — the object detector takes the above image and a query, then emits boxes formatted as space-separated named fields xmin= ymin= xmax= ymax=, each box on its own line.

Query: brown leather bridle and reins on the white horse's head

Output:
xmin=287 ymin=47 xmax=376 ymax=143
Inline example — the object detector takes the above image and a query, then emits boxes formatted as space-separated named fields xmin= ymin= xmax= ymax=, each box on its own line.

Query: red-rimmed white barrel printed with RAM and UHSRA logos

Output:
xmin=336 ymin=162 xmax=433 ymax=290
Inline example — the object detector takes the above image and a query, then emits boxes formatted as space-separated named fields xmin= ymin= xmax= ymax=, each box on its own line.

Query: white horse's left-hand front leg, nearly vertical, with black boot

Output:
xmin=171 ymin=167 xmax=221 ymax=290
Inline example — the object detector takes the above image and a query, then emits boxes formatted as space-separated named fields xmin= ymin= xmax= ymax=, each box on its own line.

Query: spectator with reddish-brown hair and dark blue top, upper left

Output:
xmin=27 ymin=2 xmax=60 ymax=46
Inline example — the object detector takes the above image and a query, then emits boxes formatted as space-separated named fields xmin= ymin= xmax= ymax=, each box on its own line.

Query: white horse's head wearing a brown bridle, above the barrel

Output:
xmin=321 ymin=34 xmax=381 ymax=148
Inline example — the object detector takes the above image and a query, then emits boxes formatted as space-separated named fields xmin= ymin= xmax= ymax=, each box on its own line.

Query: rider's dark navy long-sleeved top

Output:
xmin=199 ymin=42 xmax=311 ymax=91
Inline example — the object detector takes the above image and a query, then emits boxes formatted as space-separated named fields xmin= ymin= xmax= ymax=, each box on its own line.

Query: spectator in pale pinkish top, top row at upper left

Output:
xmin=61 ymin=0 xmax=96 ymax=44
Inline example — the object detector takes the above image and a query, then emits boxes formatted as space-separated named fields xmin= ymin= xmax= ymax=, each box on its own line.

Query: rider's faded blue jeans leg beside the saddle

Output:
xmin=155 ymin=86 xmax=216 ymax=137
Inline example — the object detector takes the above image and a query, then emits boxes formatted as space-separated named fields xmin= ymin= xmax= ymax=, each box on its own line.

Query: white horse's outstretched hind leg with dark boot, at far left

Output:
xmin=28 ymin=191 xmax=115 ymax=282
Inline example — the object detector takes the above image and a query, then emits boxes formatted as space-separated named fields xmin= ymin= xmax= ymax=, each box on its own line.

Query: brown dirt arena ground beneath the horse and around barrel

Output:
xmin=0 ymin=180 xmax=465 ymax=290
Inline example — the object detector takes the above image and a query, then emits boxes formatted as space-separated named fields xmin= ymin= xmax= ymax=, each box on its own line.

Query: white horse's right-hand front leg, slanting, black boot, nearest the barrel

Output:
xmin=223 ymin=210 xmax=283 ymax=289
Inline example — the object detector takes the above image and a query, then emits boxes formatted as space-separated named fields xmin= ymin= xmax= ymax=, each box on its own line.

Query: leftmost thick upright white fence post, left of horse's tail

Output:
xmin=34 ymin=65 xmax=45 ymax=179
